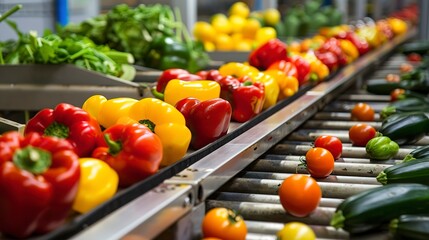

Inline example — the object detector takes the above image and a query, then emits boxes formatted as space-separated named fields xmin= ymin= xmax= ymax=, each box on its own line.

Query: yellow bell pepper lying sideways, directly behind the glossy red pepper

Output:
xmin=164 ymin=79 xmax=220 ymax=106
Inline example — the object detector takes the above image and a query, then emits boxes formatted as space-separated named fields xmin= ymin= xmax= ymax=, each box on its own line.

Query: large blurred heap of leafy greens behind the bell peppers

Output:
xmin=60 ymin=4 xmax=209 ymax=72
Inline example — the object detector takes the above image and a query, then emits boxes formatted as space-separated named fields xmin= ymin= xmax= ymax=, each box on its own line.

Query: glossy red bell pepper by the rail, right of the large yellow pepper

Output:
xmin=175 ymin=98 xmax=232 ymax=149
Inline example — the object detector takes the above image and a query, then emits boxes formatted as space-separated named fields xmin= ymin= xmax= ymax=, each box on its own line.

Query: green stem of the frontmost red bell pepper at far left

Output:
xmin=13 ymin=146 xmax=52 ymax=174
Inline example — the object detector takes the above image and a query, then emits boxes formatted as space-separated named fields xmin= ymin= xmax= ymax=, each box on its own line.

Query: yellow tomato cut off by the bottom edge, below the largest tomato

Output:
xmin=277 ymin=222 xmax=316 ymax=240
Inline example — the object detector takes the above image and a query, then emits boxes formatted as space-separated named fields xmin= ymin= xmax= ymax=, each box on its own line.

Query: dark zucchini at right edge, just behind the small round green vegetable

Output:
xmin=378 ymin=112 xmax=429 ymax=145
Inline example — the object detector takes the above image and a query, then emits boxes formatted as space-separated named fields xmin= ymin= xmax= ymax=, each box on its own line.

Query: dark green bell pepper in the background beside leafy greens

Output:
xmin=144 ymin=36 xmax=190 ymax=70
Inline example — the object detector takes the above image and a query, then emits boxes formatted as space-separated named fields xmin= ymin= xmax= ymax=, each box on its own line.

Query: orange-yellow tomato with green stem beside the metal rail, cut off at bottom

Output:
xmin=202 ymin=207 xmax=247 ymax=240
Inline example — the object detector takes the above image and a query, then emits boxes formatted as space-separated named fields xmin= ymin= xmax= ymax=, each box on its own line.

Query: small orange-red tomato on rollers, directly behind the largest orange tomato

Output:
xmin=305 ymin=147 xmax=335 ymax=178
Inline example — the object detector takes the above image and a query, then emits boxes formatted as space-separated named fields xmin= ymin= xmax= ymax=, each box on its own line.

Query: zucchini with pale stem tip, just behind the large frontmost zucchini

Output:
xmin=377 ymin=158 xmax=429 ymax=185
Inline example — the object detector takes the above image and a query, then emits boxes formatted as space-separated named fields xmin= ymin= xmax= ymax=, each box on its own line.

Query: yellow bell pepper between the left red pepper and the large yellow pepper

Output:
xmin=82 ymin=95 xmax=138 ymax=128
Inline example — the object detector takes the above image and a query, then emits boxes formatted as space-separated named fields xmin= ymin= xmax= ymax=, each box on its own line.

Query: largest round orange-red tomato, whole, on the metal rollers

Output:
xmin=278 ymin=174 xmax=322 ymax=217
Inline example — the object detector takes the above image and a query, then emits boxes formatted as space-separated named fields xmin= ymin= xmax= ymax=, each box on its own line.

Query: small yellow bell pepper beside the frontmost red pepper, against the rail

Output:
xmin=73 ymin=158 xmax=119 ymax=213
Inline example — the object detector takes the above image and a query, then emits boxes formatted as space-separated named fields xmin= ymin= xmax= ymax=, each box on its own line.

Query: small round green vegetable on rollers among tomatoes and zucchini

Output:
xmin=365 ymin=136 xmax=399 ymax=160
